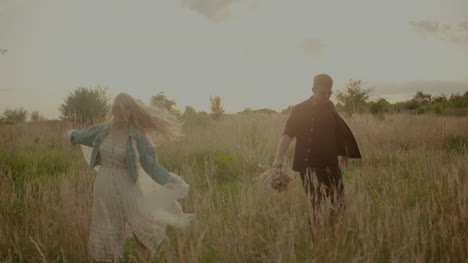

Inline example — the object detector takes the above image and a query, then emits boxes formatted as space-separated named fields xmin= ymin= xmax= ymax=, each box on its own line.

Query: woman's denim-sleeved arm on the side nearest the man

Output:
xmin=137 ymin=133 xmax=170 ymax=185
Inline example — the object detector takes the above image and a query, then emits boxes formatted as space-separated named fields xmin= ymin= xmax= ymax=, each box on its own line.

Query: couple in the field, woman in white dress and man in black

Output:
xmin=68 ymin=74 xmax=360 ymax=262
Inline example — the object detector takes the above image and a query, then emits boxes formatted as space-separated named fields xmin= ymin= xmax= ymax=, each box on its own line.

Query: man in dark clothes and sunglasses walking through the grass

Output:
xmin=272 ymin=74 xmax=361 ymax=221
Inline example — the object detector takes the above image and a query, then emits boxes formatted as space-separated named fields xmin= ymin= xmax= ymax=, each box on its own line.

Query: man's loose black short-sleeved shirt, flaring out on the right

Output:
xmin=283 ymin=96 xmax=361 ymax=172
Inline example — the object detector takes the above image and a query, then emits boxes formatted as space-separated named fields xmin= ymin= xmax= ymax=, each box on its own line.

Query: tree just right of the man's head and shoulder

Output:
xmin=336 ymin=79 xmax=371 ymax=114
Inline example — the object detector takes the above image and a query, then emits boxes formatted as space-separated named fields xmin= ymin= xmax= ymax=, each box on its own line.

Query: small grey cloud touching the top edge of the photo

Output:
xmin=182 ymin=0 xmax=238 ymax=22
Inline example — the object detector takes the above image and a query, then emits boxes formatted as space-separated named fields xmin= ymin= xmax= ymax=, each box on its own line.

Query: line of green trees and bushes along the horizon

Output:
xmin=0 ymin=79 xmax=468 ymax=125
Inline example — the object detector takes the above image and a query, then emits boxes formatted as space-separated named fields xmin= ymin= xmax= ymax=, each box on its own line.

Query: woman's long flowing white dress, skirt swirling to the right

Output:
xmin=85 ymin=135 xmax=192 ymax=262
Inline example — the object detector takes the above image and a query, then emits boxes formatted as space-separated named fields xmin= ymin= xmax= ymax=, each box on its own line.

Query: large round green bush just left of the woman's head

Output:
xmin=59 ymin=86 xmax=110 ymax=125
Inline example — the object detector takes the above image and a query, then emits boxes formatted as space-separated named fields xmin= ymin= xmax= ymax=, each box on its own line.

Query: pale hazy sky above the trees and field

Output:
xmin=0 ymin=0 xmax=468 ymax=118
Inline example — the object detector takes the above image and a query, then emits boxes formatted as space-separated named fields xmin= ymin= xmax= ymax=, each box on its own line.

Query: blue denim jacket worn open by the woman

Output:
xmin=70 ymin=123 xmax=170 ymax=185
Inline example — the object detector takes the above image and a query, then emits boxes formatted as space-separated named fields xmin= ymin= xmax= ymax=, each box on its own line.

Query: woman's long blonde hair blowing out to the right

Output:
xmin=109 ymin=93 xmax=181 ymax=145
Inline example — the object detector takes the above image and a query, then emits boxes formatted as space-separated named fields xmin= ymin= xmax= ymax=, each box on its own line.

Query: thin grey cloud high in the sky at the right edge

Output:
xmin=409 ymin=20 xmax=468 ymax=49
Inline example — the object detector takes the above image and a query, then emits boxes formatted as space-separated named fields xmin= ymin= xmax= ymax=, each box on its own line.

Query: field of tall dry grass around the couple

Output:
xmin=0 ymin=114 xmax=468 ymax=263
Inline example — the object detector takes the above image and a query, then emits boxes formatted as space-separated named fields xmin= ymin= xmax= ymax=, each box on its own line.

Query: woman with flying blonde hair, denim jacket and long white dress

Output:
xmin=69 ymin=93 xmax=193 ymax=262
